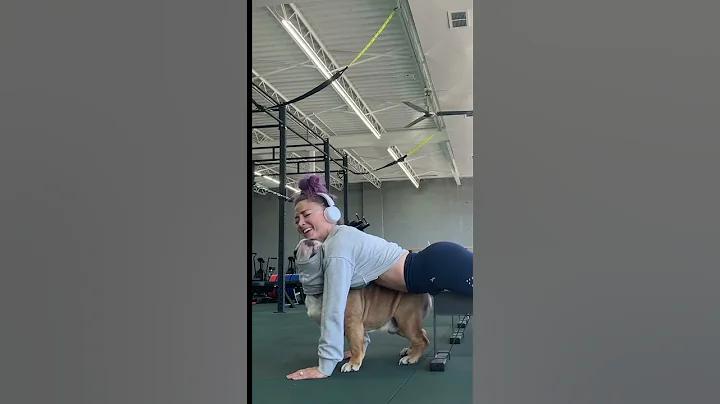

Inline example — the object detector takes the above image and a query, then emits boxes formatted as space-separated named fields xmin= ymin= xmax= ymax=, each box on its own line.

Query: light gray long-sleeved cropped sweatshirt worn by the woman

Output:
xmin=297 ymin=225 xmax=406 ymax=376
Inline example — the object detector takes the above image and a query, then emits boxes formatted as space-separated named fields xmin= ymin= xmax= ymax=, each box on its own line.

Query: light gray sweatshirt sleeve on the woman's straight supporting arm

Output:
xmin=318 ymin=258 xmax=353 ymax=376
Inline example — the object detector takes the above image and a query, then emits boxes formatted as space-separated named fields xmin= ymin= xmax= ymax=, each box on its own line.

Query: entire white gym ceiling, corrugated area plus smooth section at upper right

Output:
xmin=251 ymin=0 xmax=473 ymax=190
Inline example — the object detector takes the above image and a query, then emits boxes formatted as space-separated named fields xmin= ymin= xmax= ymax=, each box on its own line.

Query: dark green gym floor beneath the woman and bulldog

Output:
xmin=251 ymin=304 xmax=473 ymax=404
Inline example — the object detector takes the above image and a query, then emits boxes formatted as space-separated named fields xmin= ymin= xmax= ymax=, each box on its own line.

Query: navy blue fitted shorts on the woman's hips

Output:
xmin=405 ymin=241 xmax=473 ymax=296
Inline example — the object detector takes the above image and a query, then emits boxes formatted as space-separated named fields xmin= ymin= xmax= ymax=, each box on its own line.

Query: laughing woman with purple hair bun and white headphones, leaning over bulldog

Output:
xmin=287 ymin=175 xmax=473 ymax=380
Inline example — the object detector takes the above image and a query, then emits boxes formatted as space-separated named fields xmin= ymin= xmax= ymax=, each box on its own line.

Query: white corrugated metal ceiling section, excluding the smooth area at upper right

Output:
xmin=251 ymin=0 xmax=471 ymax=191
